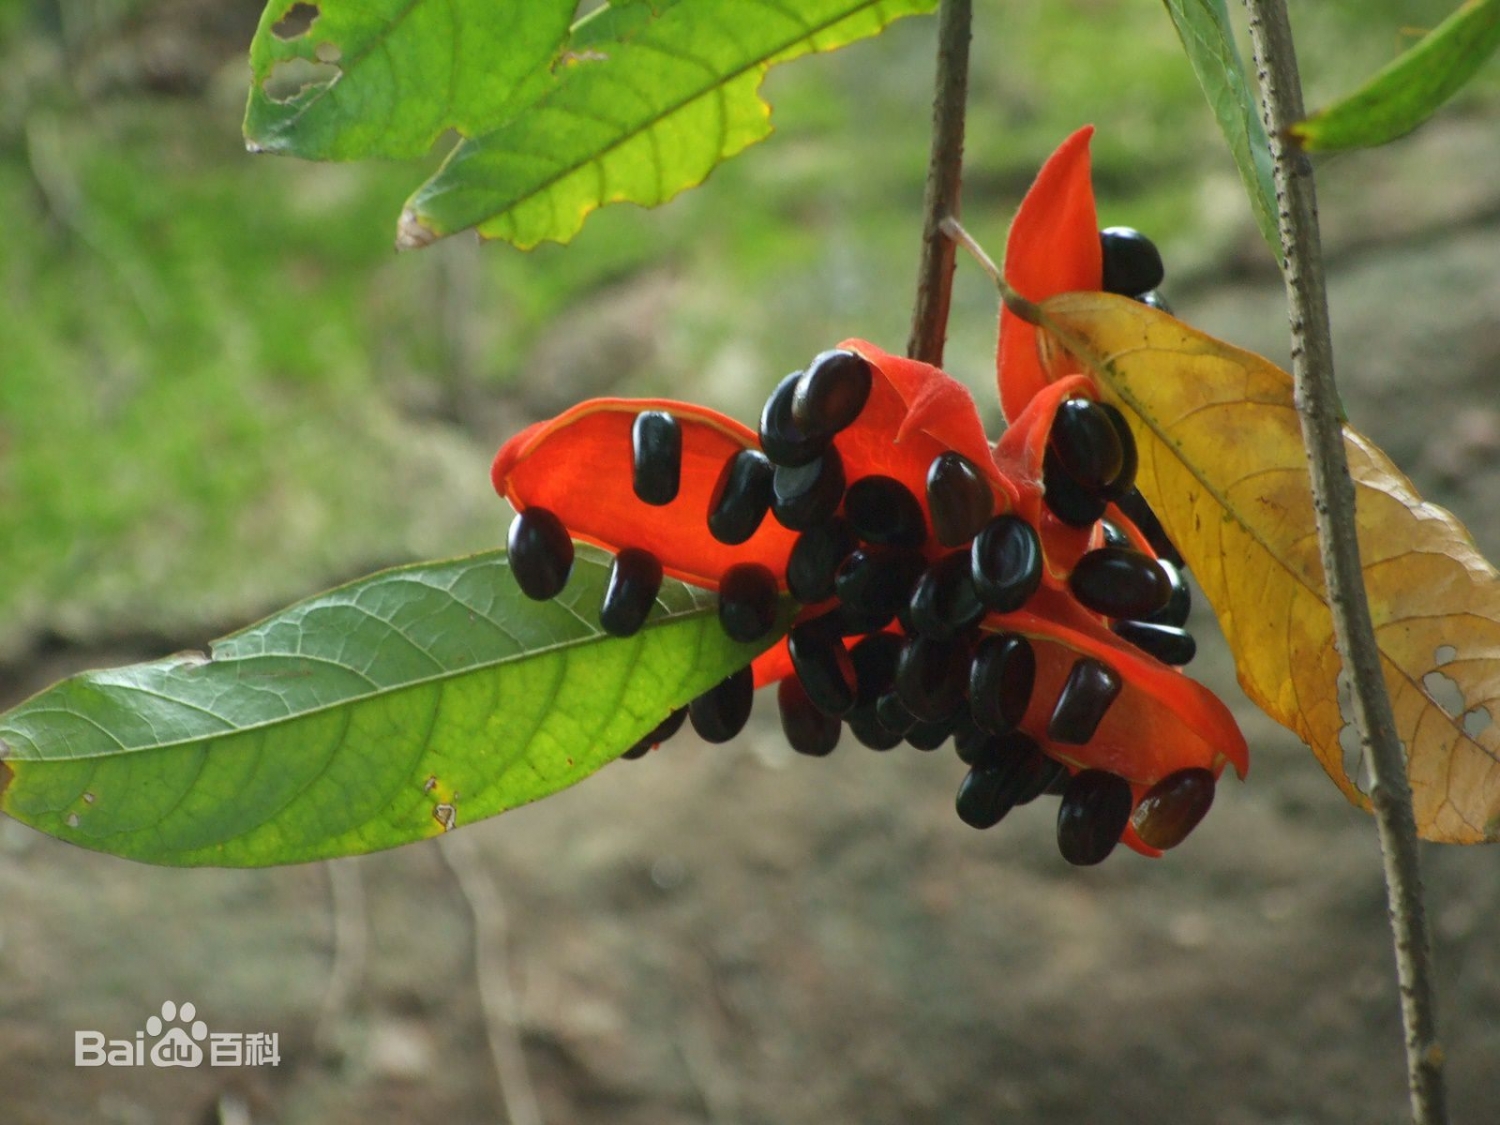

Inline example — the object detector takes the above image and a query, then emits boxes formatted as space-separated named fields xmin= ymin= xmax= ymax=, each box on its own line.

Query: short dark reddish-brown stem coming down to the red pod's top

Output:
xmin=906 ymin=0 xmax=974 ymax=366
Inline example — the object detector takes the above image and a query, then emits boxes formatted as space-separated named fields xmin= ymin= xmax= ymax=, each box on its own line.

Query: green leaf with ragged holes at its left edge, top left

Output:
xmin=245 ymin=0 xmax=576 ymax=161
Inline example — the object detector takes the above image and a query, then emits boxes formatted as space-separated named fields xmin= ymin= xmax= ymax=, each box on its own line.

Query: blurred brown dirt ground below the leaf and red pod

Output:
xmin=0 ymin=90 xmax=1500 ymax=1125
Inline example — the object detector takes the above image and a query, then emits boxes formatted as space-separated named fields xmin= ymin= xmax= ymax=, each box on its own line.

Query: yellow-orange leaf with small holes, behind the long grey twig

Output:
xmin=1038 ymin=293 xmax=1500 ymax=843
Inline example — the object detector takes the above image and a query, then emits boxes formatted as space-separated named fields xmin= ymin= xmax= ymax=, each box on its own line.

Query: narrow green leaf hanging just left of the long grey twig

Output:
xmin=1164 ymin=0 xmax=1281 ymax=261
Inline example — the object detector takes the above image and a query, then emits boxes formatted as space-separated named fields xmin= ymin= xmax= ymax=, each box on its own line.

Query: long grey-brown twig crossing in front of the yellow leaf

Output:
xmin=1245 ymin=0 xmax=1448 ymax=1125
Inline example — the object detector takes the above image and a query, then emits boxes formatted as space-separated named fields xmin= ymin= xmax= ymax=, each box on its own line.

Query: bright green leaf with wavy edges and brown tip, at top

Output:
xmin=396 ymin=0 xmax=936 ymax=248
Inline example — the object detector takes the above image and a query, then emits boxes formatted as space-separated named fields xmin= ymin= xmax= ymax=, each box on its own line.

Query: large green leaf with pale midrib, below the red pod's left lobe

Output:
xmin=0 ymin=545 xmax=791 ymax=867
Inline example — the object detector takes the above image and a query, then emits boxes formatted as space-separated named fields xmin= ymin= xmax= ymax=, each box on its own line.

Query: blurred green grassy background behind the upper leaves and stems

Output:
xmin=0 ymin=0 xmax=1500 ymax=659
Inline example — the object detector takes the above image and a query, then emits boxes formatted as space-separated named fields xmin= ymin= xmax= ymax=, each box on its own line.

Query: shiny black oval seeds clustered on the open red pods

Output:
xmin=509 ymin=228 xmax=1215 ymax=864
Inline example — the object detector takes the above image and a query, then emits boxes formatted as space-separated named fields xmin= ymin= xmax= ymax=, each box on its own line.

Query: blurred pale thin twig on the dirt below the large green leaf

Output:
xmin=438 ymin=833 xmax=542 ymax=1125
